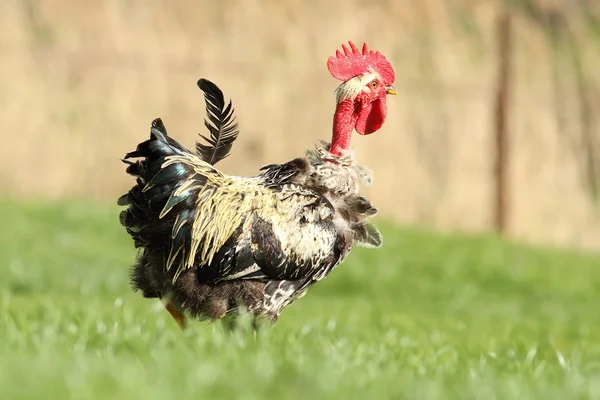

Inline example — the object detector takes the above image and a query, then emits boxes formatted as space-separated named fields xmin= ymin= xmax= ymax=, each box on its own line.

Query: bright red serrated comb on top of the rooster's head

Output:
xmin=327 ymin=41 xmax=396 ymax=85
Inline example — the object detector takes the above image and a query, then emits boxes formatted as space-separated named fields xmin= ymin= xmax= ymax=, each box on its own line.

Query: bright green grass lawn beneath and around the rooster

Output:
xmin=0 ymin=201 xmax=600 ymax=400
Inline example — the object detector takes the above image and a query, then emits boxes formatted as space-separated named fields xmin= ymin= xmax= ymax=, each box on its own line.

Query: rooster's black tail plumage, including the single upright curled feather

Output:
xmin=117 ymin=79 xmax=238 ymax=297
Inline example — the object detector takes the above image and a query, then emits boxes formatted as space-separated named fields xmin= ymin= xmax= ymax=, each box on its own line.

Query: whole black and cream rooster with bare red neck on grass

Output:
xmin=118 ymin=42 xmax=396 ymax=329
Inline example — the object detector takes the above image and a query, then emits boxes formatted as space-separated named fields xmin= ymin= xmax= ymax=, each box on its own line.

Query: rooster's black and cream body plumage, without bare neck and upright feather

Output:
xmin=121 ymin=120 xmax=381 ymax=321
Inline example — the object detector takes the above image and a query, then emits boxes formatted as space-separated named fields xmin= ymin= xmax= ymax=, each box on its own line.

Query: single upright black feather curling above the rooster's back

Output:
xmin=196 ymin=79 xmax=239 ymax=165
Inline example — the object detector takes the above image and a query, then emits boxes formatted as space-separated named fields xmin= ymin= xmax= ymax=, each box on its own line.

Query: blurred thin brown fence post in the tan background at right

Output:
xmin=493 ymin=5 xmax=512 ymax=233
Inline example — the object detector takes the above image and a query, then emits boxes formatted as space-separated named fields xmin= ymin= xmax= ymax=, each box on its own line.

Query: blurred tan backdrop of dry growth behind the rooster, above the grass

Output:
xmin=0 ymin=0 xmax=600 ymax=249
